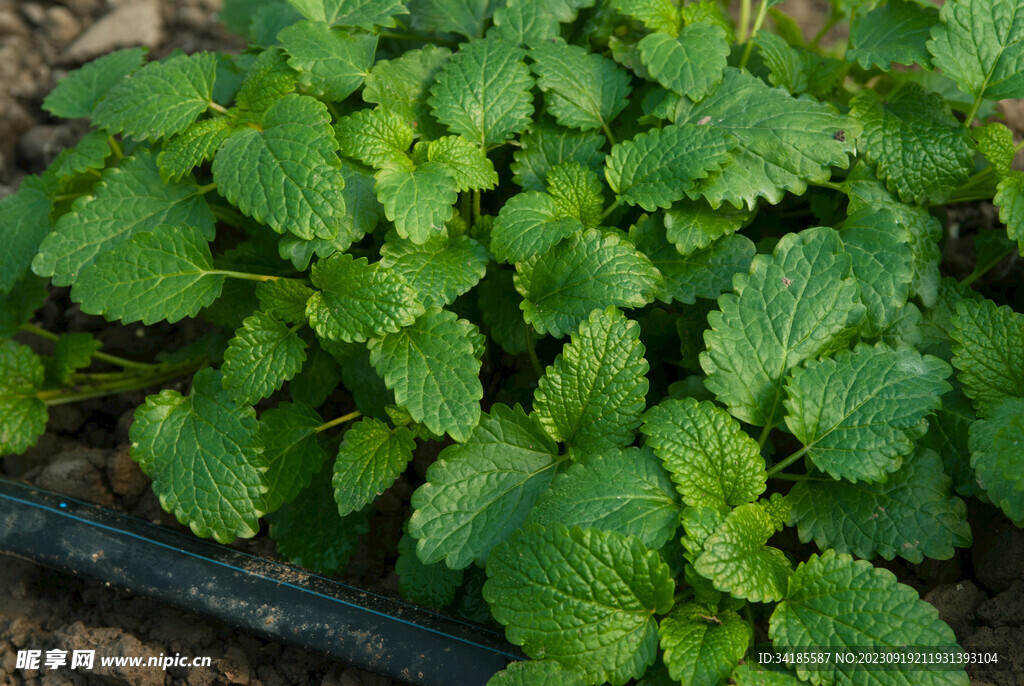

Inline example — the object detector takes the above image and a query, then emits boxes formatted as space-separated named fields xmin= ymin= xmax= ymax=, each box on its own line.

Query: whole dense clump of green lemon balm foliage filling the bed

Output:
xmin=0 ymin=0 xmax=1024 ymax=684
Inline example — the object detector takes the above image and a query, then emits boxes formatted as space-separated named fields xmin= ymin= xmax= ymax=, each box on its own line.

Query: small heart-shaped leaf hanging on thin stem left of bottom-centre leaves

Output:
xmin=332 ymin=417 xmax=416 ymax=517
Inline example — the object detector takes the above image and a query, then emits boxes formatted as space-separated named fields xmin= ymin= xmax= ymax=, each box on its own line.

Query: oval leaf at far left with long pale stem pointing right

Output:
xmin=71 ymin=224 xmax=224 ymax=325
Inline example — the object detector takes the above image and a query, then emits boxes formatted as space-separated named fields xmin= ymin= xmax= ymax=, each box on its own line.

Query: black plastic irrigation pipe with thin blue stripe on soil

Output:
xmin=0 ymin=478 xmax=522 ymax=686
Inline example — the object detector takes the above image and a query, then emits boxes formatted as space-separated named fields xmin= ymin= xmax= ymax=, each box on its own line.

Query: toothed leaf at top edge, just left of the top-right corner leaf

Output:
xmin=846 ymin=0 xmax=939 ymax=72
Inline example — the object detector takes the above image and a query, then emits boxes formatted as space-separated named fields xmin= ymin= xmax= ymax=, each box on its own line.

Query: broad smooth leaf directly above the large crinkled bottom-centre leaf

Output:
xmin=526 ymin=447 xmax=680 ymax=550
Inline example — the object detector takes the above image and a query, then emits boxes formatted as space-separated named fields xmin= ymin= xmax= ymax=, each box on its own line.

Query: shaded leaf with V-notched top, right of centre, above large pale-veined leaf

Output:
xmin=630 ymin=217 xmax=757 ymax=304
